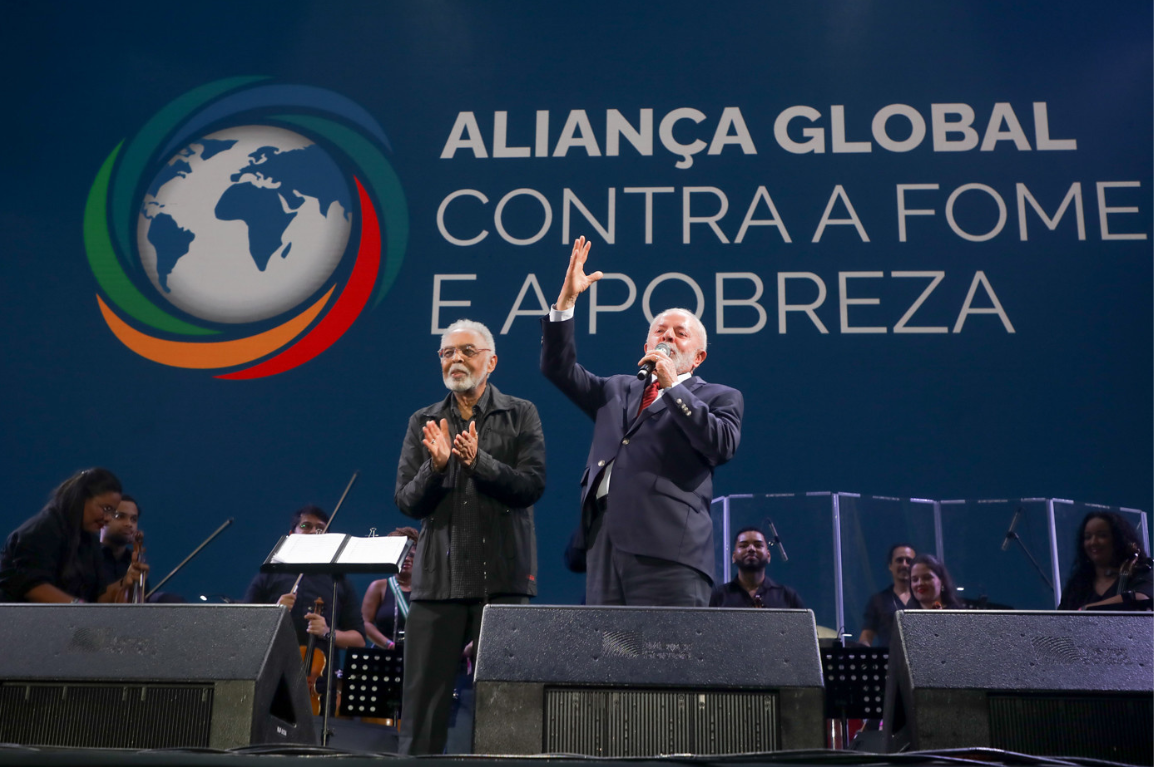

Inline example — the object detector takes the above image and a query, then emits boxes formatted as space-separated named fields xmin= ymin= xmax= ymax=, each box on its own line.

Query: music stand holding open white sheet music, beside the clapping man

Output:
xmin=261 ymin=533 xmax=413 ymax=746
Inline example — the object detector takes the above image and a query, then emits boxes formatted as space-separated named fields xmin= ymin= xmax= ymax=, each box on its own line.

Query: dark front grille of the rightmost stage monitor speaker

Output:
xmin=989 ymin=693 xmax=1154 ymax=765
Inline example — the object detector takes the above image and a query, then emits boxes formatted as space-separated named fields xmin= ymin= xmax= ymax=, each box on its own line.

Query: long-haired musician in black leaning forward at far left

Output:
xmin=0 ymin=468 xmax=148 ymax=603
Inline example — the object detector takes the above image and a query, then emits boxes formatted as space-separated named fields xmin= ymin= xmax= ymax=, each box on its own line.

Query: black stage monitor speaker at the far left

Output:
xmin=0 ymin=604 xmax=317 ymax=749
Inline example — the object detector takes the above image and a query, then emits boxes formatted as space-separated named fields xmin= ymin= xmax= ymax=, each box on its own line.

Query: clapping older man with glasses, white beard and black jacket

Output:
xmin=394 ymin=319 xmax=545 ymax=754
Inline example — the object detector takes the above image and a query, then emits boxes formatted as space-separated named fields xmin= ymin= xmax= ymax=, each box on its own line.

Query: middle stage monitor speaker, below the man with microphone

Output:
xmin=474 ymin=604 xmax=824 ymax=757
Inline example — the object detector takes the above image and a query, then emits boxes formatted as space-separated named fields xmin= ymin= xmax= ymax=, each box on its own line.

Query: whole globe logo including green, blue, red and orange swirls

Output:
xmin=84 ymin=77 xmax=409 ymax=381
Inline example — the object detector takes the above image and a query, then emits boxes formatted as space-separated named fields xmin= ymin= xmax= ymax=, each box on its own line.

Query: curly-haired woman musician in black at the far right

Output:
xmin=1058 ymin=511 xmax=1154 ymax=610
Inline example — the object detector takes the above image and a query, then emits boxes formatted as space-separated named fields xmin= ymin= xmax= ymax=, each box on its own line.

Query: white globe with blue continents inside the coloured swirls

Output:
xmin=136 ymin=126 xmax=352 ymax=323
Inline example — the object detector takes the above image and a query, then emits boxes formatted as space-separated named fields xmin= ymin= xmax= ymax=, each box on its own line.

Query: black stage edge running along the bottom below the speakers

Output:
xmin=0 ymin=744 xmax=1144 ymax=767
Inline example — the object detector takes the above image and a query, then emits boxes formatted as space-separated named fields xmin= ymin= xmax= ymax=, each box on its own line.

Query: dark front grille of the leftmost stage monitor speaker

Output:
xmin=0 ymin=683 xmax=212 ymax=749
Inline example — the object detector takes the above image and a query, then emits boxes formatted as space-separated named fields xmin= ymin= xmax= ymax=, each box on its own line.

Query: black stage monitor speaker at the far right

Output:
xmin=883 ymin=610 xmax=1154 ymax=765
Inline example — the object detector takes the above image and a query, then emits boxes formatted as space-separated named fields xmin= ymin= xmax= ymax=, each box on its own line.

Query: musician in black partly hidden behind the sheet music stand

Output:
xmin=241 ymin=505 xmax=365 ymax=651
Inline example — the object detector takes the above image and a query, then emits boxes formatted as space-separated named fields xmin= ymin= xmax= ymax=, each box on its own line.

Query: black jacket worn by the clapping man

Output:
xmin=394 ymin=383 xmax=545 ymax=600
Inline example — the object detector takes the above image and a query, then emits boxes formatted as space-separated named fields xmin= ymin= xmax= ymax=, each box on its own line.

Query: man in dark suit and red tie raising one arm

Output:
xmin=541 ymin=232 xmax=744 ymax=607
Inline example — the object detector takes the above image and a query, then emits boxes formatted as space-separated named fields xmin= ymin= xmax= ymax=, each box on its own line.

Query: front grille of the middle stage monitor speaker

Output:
xmin=544 ymin=687 xmax=780 ymax=757
